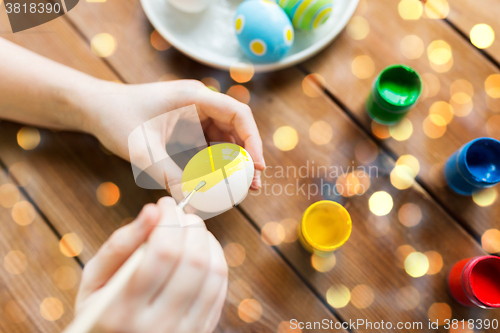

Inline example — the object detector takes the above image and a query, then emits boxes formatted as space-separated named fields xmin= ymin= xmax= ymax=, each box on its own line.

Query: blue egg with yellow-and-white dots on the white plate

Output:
xmin=234 ymin=0 xmax=294 ymax=62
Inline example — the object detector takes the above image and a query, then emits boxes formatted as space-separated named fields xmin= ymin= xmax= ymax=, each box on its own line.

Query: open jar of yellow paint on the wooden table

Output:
xmin=299 ymin=200 xmax=352 ymax=256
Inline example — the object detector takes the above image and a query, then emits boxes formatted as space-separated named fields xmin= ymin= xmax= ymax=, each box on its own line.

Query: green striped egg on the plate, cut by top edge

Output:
xmin=279 ymin=0 xmax=333 ymax=30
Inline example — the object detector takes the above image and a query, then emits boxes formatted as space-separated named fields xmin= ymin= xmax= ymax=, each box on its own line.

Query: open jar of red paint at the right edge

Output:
xmin=448 ymin=256 xmax=500 ymax=309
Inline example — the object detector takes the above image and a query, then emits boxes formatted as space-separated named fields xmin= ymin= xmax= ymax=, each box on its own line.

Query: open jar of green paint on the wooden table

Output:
xmin=366 ymin=65 xmax=422 ymax=125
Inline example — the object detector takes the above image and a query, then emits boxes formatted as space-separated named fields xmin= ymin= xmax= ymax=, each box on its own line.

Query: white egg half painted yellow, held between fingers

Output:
xmin=181 ymin=143 xmax=254 ymax=213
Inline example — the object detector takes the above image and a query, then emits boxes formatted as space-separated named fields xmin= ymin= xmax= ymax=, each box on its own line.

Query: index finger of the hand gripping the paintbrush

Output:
xmin=127 ymin=197 xmax=186 ymax=302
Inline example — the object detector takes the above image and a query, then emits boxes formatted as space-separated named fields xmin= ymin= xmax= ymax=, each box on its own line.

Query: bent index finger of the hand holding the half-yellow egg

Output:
xmin=196 ymin=89 xmax=266 ymax=171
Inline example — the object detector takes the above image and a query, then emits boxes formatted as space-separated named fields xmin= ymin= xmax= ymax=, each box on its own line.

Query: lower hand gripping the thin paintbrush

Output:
xmin=76 ymin=197 xmax=228 ymax=333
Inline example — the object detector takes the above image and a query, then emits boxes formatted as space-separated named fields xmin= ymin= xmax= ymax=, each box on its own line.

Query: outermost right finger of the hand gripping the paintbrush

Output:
xmin=177 ymin=233 xmax=228 ymax=333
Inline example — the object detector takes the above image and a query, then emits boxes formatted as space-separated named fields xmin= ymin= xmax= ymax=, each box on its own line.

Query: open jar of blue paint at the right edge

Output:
xmin=445 ymin=138 xmax=500 ymax=195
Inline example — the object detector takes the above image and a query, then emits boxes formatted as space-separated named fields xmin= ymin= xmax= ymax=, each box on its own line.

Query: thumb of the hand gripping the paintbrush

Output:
xmin=78 ymin=204 xmax=160 ymax=299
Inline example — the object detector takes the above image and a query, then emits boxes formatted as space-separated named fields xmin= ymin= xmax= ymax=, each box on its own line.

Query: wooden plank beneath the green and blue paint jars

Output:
xmin=303 ymin=0 xmax=500 ymax=239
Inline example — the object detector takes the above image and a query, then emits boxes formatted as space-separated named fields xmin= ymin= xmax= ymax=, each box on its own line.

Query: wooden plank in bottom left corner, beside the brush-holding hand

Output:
xmin=0 ymin=169 xmax=81 ymax=332
